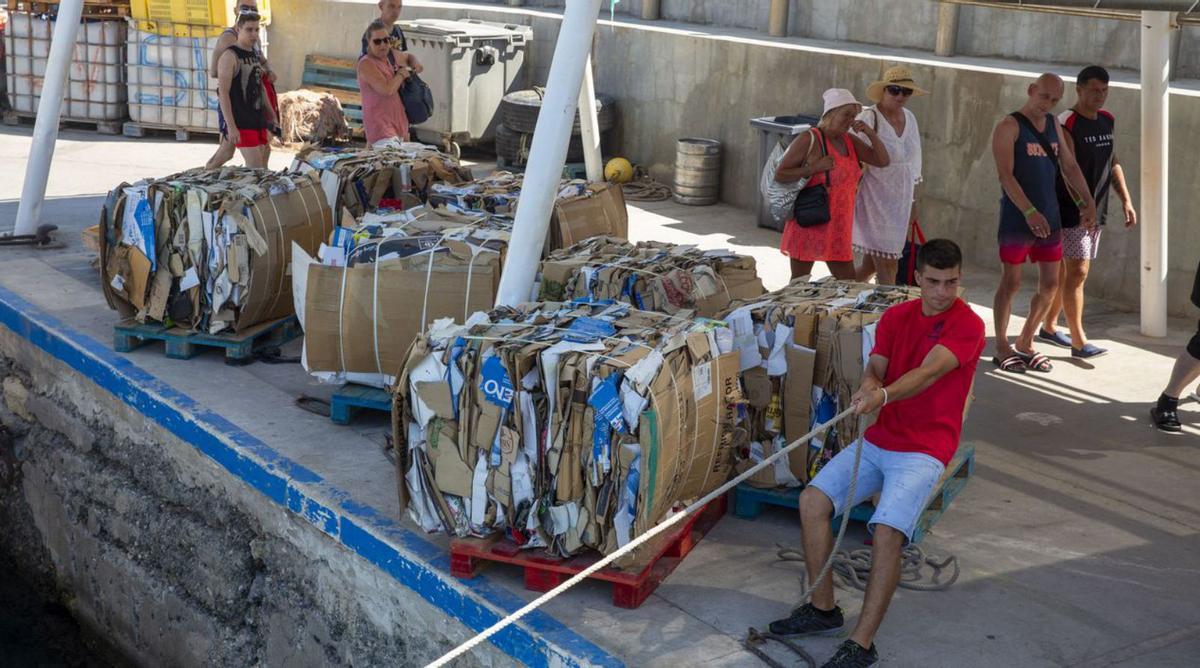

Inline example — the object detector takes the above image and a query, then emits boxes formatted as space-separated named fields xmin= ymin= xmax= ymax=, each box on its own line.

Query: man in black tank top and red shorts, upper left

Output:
xmin=217 ymin=13 xmax=274 ymax=168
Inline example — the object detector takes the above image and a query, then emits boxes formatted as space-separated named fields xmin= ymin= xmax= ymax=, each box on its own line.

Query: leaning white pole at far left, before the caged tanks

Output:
xmin=13 ymin=0 xmax=83 ymax=234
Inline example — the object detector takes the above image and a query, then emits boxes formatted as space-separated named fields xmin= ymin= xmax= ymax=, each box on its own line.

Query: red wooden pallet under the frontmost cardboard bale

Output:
xmin=450 ymin=497 xmax=727 ymax=608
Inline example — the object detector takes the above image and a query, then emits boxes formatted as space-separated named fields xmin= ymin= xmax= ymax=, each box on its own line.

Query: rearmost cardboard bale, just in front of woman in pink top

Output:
xmin=292 ymin=144 xmax=470 ymax=218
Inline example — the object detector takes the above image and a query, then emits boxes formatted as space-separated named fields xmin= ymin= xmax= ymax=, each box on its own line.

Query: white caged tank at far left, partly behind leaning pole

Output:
xmin=6 ymin=12 xmax=126 ymax=121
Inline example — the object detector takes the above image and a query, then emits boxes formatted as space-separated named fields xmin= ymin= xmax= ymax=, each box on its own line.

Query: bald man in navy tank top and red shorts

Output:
xmin=991 ymin=74 xmax=1096 ymax=373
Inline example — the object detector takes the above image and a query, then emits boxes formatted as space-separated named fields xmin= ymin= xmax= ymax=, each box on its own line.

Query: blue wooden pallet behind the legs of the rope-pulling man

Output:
xmin=733 ymin=444 xmax=974 ymax=543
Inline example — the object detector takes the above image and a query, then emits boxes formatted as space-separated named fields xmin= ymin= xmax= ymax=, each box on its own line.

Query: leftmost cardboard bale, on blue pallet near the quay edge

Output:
xmin=100 ymin=167 xmax=332 ymax=333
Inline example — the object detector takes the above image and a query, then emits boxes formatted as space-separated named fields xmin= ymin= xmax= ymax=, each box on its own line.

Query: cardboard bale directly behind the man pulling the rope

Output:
xmin=724 ymin=281 xmax=919 ymax=487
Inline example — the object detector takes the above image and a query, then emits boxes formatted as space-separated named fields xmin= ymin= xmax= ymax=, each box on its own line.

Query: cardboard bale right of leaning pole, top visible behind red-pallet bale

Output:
xmin=541 ymin=236 xmax=763 ymax=318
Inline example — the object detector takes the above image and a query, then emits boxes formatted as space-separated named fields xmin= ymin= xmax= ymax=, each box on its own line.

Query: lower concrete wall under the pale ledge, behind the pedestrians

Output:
xmin=272 ymin=2 xmax=1200 ymax=313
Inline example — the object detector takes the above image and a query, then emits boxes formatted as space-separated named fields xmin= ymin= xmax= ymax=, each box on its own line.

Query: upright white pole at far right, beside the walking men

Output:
xmin=1140 ymin=12 xmax=1171 ymax=337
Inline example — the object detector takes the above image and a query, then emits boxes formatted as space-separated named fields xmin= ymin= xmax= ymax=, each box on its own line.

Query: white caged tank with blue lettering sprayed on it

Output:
xmin=127 ymin=28 xmax=220 ymax=132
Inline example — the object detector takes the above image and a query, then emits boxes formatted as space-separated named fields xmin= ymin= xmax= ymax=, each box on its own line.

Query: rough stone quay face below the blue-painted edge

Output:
xmin=0 ymin=327 xmax=512 ymax=667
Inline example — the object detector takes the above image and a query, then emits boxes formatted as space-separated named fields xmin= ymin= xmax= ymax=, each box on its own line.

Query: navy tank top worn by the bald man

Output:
xmin=1000 ymin=114 xmax=1062 ymax=233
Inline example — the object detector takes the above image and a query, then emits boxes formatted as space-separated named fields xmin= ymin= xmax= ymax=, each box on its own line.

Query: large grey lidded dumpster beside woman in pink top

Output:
xmin=398 ymin=19 xmax=533 ymax=155
